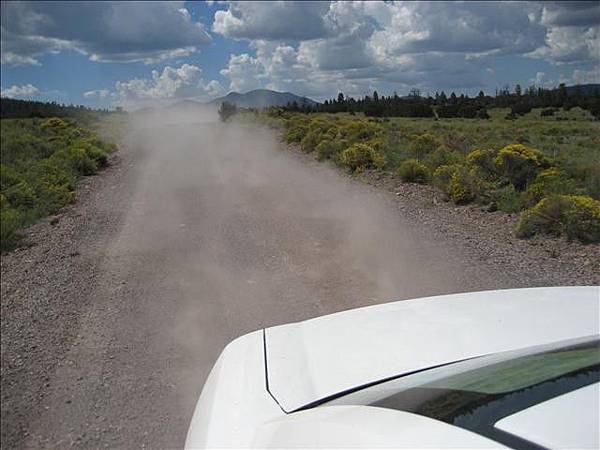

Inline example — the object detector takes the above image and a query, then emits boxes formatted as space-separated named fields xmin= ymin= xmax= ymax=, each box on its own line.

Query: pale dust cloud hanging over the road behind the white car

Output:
xmin=109 ymin=109 xmax=500 ymax=435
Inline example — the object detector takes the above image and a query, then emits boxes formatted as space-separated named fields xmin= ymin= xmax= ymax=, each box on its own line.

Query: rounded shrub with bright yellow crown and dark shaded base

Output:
xmin=494 ymin=144 xmax=548 ymax=191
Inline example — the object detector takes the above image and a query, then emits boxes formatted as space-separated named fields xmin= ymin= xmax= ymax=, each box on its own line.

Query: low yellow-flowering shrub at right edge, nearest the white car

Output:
xmin=516 ymin=195 xmax=600 ymax=243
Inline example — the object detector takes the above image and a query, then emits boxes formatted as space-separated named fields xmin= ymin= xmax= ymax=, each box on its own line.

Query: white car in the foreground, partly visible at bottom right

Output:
xmin=186 ymin=286 xmax=600 ymax=449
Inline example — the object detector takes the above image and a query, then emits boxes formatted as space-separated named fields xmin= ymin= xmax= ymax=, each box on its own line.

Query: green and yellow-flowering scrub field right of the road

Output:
xmin=237 ymin=107 xmax=600 ymax=243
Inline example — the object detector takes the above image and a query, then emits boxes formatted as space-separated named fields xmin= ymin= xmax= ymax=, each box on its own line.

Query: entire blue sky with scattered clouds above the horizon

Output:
xmin=1 ymin=1 xmax=600 ymax=109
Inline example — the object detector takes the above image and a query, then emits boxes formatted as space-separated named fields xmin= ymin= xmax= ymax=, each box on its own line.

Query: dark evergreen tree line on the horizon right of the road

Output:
xmin=285 ymin=84 xmax=600 ymax=119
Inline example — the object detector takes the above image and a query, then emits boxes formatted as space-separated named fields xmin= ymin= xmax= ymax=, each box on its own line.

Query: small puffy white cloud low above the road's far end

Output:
xmin=114 ymin=64 xmax=223 ymax=106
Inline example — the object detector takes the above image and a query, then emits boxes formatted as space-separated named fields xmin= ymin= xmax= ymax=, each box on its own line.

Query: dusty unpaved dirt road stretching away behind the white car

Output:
xmin=2 ymin=114 xmax=540 ymax=449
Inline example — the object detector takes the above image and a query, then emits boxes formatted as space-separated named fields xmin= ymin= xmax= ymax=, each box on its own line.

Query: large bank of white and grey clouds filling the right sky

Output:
xmin=213 ymin=1 xmax=600 ymax=96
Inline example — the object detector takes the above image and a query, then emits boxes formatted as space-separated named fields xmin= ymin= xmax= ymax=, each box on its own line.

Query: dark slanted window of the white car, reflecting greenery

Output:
xmin=327 ymin=339 xmax=600 ymax=448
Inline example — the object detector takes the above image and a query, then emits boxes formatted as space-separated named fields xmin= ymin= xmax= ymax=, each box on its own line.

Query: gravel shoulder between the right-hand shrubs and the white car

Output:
xmin=362 ymin=172 xmax=600 ymax=286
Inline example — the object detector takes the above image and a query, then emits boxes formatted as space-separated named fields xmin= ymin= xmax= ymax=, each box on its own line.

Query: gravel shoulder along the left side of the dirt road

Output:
xmin=0 ymin=156 xmax=132 ymax=449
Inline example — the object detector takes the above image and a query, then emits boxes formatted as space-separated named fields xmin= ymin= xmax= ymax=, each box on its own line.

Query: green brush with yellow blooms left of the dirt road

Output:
xmin=0 ymin=99 xmax=123 ymax=251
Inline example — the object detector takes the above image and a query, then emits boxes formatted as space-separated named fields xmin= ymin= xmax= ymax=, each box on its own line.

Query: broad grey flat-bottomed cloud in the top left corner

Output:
xmin=2 ymin=1 xmax=211 ymax=65
